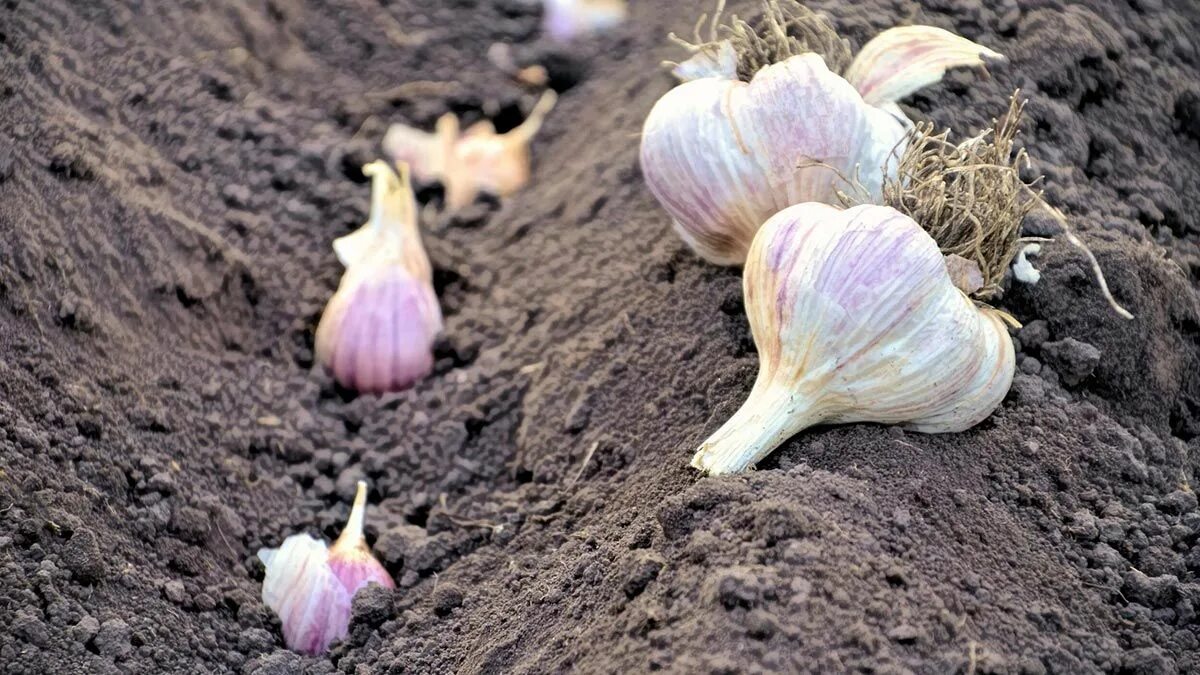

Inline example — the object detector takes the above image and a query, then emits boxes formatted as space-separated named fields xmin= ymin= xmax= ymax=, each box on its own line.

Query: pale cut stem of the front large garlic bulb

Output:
xmin=691 ymin=383 xmax=822 ymax=476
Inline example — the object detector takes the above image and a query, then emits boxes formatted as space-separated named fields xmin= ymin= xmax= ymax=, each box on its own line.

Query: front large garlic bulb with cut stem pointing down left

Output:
xmin=691 ymin=203 xmax=1015 ymax=474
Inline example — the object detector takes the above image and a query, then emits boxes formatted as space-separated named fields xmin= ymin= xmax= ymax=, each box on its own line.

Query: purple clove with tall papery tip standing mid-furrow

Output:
xmin=316 ymin=161 xmax=442 ymax=393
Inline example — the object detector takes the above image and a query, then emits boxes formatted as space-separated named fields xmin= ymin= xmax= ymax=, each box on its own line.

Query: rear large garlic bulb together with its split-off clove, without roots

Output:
xmin=641 ymin=26 xmax=1001 ymax=264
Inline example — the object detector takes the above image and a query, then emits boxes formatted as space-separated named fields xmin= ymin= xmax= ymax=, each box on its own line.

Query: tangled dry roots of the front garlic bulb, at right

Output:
xmin=883 ymin=92 xmax=1040 ymax=300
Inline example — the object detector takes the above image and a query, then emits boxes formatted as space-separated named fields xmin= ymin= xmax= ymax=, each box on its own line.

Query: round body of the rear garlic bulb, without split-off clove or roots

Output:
xmin=641 ymin=54 xmax=907 ymax=264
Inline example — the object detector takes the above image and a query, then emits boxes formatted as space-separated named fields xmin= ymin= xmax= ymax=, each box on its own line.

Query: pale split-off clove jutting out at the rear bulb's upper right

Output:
xmin=845 ymin=25 xmax=1004 ymax=106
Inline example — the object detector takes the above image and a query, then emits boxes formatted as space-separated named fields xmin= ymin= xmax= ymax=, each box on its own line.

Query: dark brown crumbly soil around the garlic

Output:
xmin=0 ymin=0 xmax=1200 ymax=675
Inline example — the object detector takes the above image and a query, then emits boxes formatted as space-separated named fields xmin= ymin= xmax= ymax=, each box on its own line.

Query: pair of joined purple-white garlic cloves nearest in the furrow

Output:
xmin=258 ymin=480 xmax=396 ymax=655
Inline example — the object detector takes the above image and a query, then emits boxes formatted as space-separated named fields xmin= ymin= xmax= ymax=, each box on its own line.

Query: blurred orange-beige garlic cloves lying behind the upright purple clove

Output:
xmin=383 ymin=90 xmax=558 ymax=210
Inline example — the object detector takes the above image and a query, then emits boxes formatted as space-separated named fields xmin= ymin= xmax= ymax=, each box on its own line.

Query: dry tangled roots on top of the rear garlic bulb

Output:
xmin=671 ymin=0 xmax=852 ymax=82
